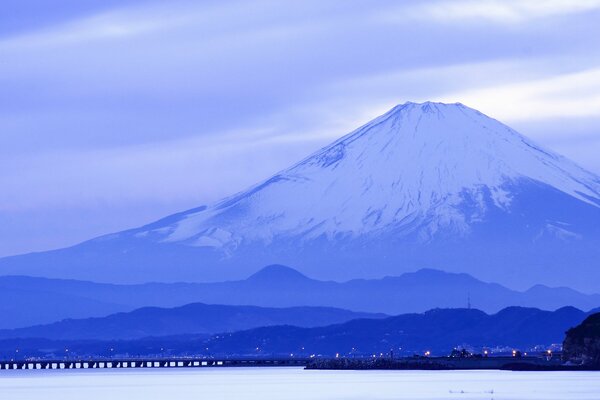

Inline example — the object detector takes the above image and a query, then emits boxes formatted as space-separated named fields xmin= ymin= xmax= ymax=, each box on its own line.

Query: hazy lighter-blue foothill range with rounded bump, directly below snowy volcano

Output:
xmin=0 ymin=265 xmax=600 ymax=329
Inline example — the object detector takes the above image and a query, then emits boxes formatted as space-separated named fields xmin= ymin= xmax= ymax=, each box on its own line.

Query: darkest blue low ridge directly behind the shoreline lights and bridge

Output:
xmin=0 ymin=306 xmax=590 ymax=358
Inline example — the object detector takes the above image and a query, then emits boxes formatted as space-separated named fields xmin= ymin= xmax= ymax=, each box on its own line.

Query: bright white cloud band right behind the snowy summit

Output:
xmin=285 ymin=57 xmax=600 ymax=129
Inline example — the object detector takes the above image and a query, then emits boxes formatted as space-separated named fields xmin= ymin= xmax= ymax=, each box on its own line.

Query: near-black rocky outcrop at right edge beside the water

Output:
xmin=563 ymin=313 xmax=600 ymax=367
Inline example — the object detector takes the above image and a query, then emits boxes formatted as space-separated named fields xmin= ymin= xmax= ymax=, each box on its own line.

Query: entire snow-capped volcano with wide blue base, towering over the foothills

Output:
xmin=0 ymin=102 xmax=600 ymax=292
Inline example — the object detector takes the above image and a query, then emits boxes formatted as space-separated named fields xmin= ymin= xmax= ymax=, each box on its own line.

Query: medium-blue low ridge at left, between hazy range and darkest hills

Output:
xmin=0 ymin=303 xmax=386 ymax=340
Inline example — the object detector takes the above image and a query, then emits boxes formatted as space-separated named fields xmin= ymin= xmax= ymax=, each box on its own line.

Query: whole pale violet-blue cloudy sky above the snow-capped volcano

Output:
xmin=0 ymin=0 xmax=600 ymax=256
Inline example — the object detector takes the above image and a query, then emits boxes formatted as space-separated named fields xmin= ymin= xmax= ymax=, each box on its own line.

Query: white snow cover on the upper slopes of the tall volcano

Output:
xmin=137 ymin=103 xmax=600 ymax=251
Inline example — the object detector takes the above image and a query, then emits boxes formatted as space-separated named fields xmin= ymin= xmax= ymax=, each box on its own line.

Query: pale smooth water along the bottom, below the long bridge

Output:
xmin=0 ymin=368 xmax=600 ymax=400
